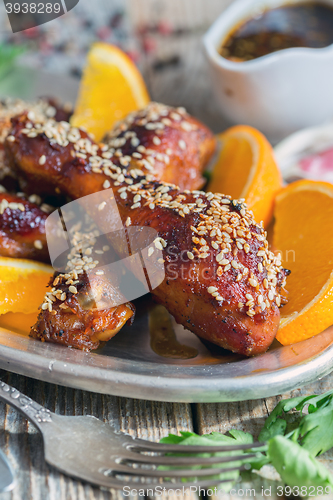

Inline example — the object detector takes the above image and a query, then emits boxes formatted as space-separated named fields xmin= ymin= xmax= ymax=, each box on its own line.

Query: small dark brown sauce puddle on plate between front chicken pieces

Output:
xmin=149 ymin=306 xmax=198 ymax=359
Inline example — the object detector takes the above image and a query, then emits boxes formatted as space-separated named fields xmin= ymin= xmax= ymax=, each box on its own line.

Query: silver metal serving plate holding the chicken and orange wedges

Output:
xmin=0 ymin=300 xmax=333 ymax=403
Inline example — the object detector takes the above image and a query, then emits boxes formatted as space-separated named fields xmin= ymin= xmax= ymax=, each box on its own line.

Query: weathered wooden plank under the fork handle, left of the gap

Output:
xmin=0 ymin=370 xmax=193 ymax=500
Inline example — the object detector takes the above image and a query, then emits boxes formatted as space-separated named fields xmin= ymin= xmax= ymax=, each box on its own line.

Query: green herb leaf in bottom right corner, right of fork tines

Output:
xmin=268 ymin=436 xmax=333 ymax=488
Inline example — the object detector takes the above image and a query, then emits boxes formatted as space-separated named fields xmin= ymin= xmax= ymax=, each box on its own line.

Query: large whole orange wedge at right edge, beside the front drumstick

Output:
xmin=273 ymin=180 xmax=333 ymax=345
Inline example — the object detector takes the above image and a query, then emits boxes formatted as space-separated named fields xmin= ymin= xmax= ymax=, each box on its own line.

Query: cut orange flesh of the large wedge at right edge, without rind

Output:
xmin=274 ymin=190 xmax=333 ymax=318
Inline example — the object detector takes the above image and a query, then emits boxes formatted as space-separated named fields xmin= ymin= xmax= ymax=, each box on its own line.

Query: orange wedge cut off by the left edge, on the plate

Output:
xmin=0 ymin=257 xmax=54 ymax=314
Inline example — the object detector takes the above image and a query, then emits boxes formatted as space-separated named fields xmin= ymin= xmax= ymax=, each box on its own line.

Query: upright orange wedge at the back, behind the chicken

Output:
xmin=71 ymin=42 xmax=150 ymax=141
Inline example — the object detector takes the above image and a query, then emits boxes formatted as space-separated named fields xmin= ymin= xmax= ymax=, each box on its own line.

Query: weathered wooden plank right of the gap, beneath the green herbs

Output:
xmin=194 ymin=374 xmax=333 ymax=500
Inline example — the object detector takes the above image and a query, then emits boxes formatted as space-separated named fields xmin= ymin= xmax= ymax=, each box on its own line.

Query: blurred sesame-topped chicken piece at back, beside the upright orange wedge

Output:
xmin=103 ymin=105 xmax=216 ymax=189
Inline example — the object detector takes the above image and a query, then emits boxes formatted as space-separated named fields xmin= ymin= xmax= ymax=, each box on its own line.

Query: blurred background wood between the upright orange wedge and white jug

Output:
xmin=128 ymin=0 xmax=230 ymax=132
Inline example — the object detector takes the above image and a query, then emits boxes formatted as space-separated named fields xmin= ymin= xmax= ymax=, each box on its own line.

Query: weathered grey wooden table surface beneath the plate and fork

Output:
xmin=0 ymin=0 xmax=333 ymax=500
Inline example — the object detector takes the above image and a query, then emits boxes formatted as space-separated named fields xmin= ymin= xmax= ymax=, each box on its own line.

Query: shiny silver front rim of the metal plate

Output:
xmin=0 ymin=327 xmax=333 ymax=403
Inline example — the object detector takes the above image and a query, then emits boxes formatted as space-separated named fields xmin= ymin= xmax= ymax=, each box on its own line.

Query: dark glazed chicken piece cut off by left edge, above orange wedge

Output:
xmin=0 ymin=192 xmax=49 ymax=262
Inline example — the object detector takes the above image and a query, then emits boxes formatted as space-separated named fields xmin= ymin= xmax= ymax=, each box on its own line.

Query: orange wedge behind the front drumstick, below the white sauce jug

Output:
xmin=207 ymin=125 xmax=282 ymax=226
